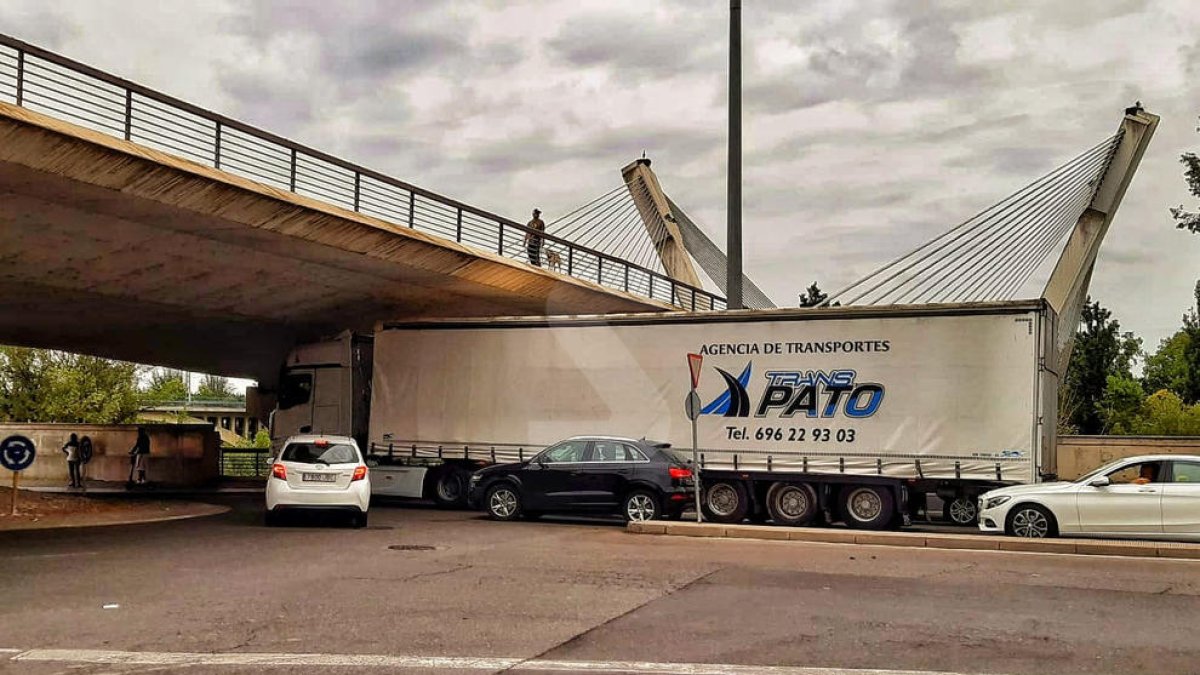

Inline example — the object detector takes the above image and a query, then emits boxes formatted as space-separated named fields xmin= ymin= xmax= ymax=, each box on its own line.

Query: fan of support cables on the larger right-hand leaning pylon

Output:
xmin=826 ymin=132 xmax=1122 ymax=305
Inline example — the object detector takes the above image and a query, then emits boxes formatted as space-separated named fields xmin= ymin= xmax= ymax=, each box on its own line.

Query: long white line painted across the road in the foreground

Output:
xmin=13 ymin=650 xmax=993 ymax=675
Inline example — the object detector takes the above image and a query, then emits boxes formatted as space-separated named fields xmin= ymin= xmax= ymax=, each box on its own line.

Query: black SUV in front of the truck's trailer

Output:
xmin=468 ymin=436 xmax=695 ymax=520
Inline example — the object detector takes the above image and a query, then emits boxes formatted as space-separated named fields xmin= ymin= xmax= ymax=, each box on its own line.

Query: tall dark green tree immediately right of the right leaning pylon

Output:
xmin=1060 ymin=298 xmax=1141 ymax=434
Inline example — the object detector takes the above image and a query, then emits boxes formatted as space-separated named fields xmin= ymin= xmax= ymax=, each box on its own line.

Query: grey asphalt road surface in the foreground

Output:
xmin=0 ymin=497 xmax=1200 ymax=674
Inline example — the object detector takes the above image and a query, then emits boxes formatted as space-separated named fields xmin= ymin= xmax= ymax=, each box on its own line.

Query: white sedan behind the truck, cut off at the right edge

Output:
xmin=979 ymin=455 xmax=1200 ymax=539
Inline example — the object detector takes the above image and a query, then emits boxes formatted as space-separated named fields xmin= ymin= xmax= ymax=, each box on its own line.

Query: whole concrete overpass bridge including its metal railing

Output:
xmin=0 ymin=35 xmax=725 ymax=383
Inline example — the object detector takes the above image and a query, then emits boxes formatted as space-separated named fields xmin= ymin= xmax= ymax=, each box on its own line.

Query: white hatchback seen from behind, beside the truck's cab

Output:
xmin=265 ymin=435 xmax=371 ymax=527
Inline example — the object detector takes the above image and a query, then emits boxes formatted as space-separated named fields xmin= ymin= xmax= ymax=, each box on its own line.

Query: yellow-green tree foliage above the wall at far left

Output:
xmin=0 ymin=347 xmax=140 ymax=424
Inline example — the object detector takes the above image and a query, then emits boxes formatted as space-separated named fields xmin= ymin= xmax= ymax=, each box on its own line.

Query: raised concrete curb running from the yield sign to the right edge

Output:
xmin=625 ymin=522 xmax=1200 ymax=560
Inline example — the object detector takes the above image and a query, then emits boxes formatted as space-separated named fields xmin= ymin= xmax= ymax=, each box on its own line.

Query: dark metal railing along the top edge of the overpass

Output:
xmin=0 ymin=35 xmax=726 ymax=310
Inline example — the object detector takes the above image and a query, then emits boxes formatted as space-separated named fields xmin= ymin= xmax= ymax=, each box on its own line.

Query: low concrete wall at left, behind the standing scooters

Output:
xmin=0 ymin=424 xmax=221 ymax=485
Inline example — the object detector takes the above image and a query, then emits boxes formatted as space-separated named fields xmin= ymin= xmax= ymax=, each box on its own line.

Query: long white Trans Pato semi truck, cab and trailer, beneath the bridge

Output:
xmin=271 ymin=300 xmax=1058 ymax=527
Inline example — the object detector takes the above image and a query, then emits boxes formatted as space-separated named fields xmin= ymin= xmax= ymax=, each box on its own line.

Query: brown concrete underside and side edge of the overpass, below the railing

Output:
xmin=0 ymin=103 xmax=668 ymax=382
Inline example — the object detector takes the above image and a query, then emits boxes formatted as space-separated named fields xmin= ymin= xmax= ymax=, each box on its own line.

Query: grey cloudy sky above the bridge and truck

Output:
xmin=0 ymin=0 xmax=1200 ymax=347
